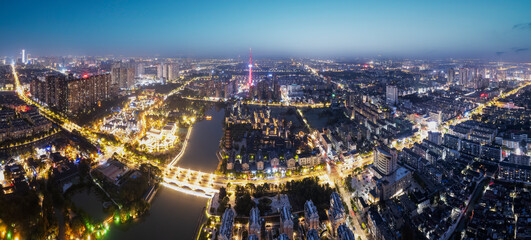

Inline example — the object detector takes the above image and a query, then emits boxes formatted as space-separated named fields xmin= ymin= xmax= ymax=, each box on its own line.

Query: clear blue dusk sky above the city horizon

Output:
xmin=0 ymin=0 xmax=531 ymax=61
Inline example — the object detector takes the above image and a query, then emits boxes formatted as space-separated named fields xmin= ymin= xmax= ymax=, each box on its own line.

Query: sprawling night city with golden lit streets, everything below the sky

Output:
xmin=0 ymin=45 xmax=531 ymax=240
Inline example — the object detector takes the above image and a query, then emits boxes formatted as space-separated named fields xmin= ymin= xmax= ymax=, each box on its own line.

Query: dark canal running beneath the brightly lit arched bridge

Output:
xmin=105 ymin=107 xmax=225 ymax=240
